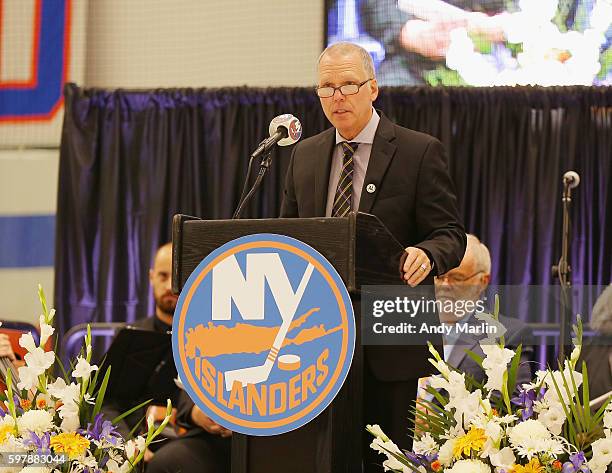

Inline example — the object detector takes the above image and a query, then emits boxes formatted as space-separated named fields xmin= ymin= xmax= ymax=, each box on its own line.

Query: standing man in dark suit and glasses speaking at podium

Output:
xmin=281 ymin=43 xmax=465 ymax=468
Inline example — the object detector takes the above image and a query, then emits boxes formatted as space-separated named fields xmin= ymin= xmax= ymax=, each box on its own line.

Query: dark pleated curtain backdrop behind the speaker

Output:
xmin=55 ymin=84 xmax=612 ymax=332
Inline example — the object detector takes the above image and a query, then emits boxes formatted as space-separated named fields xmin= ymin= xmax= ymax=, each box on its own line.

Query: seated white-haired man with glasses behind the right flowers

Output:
xmin=434 ymin=234 xmax=533 ymax=386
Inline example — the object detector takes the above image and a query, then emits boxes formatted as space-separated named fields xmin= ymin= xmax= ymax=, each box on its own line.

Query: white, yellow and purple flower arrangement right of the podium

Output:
xmin=367 ymin=302 xmax=612 ymax=473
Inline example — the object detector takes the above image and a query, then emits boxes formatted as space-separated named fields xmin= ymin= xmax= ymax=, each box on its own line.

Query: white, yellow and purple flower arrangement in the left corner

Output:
xmin=0 ymin=286 xmax=172 ymax=473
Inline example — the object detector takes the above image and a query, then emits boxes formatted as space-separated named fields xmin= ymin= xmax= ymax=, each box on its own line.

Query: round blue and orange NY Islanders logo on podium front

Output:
xmin=172 ymin=234 xmax=355 ymax=435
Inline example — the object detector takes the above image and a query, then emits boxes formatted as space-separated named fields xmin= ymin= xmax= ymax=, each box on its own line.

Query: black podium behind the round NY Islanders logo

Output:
xmin=172 ymin=213 xmax=428 ymax=473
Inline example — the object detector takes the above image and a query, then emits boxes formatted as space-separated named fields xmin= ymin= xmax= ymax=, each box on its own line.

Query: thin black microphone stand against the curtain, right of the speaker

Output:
xmin=552 ymin=180 xmax=572 ymax=360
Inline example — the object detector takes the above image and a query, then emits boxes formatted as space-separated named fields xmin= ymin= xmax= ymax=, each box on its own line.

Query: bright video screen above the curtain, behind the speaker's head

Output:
xmin=326 ymin=0 xmax=612 ymax=86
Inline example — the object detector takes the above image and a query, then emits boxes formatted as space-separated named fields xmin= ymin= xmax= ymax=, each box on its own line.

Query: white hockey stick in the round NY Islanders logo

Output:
xmin=224 ymin=263 xmax=314 ymax=391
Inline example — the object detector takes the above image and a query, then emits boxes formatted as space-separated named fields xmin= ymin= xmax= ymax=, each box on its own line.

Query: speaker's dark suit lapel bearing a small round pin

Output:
xmin=358 ymin=112 xmax=397 ymax=213
